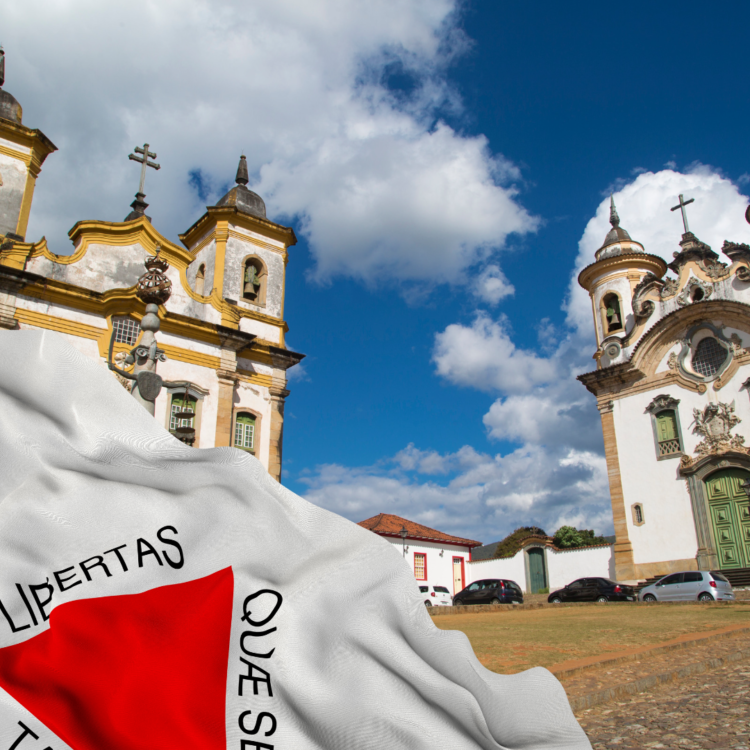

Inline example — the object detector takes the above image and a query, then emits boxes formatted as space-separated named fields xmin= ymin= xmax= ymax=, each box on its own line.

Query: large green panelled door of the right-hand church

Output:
xmin=705 ymin=469 xmax=750 ymax=570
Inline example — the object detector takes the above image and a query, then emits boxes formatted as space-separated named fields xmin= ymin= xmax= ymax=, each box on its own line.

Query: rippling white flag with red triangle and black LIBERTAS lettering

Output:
xmin=0 ymin=331 xmax=590 ymax=750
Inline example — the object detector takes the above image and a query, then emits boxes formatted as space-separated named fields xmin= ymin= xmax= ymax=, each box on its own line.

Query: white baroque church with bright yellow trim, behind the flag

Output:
xmin=0 ymin=50 xmax=304 ymax=480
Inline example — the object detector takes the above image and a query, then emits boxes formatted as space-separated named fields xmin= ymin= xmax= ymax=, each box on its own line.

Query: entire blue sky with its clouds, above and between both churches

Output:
xmin=5 ymin=0 xmax=750 ymax=543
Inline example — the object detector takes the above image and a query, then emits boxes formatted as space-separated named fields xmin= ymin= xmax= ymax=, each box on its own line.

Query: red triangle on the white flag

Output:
xmin=0 ymin=568 xmax=234 ymax=750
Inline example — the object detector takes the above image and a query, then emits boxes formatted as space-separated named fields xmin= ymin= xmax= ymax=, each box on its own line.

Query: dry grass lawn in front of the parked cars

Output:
xmin=433 ymin=603 xmax=750 ymax=674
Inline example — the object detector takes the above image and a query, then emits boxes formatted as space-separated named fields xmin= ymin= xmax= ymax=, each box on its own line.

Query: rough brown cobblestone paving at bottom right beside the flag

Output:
xmin=563 ymin=637 xmax=750 ymax=750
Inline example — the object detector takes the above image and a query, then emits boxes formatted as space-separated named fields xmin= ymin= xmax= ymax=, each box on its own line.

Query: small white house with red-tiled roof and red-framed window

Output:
xmin=359 ymin=513 xmax=482 ymax=594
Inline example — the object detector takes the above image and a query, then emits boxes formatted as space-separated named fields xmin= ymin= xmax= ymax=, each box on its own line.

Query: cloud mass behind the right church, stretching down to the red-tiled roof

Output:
xmin=307 ymin=165 xmax=750 ymax=543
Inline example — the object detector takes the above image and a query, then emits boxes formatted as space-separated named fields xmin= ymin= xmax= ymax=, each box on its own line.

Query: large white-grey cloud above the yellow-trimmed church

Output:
xmin=3 ymin=0 xmax=536 ymax=293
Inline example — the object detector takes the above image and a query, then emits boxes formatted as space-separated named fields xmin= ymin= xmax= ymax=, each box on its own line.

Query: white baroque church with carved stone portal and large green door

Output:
xmin=578 ymin=196 xmax=750 ymax=582
